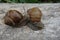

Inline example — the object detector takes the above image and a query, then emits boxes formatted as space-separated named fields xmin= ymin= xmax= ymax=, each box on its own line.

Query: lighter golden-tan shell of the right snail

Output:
xmin=27 ymin=7 xmax=42 ymax=22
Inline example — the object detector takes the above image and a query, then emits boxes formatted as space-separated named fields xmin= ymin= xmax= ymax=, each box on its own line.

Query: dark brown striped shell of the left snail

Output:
xmin=4 ymin=10 xmax=23 ymax=26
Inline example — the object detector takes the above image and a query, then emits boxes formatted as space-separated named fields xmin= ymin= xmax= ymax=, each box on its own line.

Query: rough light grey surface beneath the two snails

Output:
xmin=0 ymin=3 xmax=60 ymax=40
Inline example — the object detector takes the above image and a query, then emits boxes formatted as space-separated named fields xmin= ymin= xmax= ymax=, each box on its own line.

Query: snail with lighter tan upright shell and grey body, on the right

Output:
xmin=27 ymin=7 xmax=44 ymax=29
